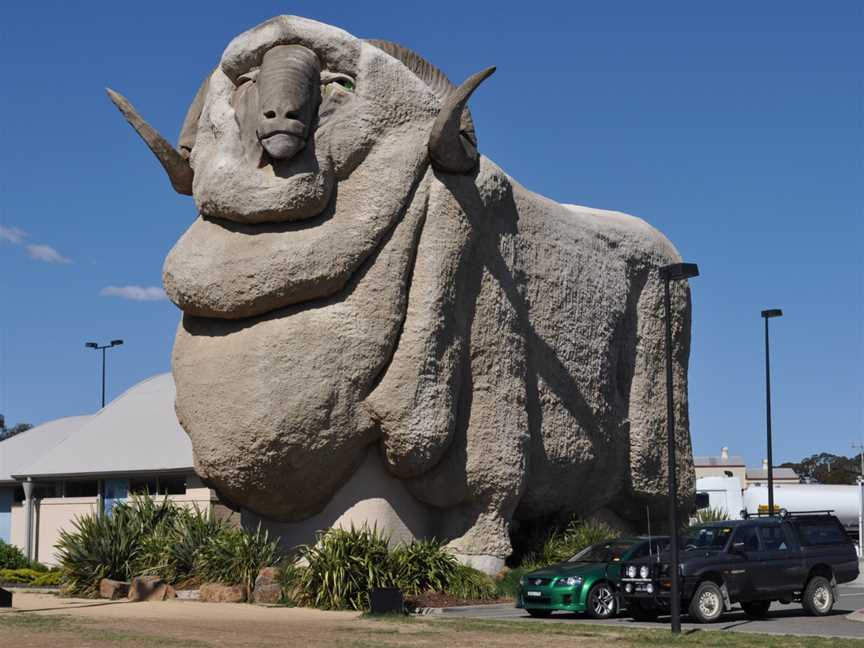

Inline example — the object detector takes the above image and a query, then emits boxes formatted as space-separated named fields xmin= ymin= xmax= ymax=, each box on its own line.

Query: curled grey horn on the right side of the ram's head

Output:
xmin=429 ymin=67 xmax=495 ymax=173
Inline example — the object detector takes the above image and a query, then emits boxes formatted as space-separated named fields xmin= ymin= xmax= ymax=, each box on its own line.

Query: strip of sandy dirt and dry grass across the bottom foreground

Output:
xmin=0 ymin=592 xmax=861 ymax=648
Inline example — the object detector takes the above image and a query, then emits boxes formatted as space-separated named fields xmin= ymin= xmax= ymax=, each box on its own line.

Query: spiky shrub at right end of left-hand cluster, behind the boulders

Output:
xmin=192 ymin=523 xmax=281 ymax=592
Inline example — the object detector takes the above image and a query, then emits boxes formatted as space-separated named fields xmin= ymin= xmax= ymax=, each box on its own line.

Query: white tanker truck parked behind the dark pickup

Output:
xmin=696 ymin=477 xmax=862 ymax=537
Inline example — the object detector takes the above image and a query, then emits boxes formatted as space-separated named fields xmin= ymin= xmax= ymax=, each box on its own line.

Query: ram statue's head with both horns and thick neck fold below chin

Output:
xmin=109 ymin=16 xmax=494 ymax=319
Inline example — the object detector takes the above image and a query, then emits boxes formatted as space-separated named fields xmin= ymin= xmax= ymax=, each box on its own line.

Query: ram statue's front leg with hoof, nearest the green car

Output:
xmin=408 ymin=255 xmax=530 ymax=573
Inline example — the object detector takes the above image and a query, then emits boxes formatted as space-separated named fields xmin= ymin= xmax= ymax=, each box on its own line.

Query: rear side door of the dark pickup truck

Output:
xmin=753 ymin=520 xmax=804 ymax=596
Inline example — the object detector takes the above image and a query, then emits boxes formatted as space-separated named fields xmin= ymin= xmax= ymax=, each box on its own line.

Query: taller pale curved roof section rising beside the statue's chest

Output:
xmin=12 ymin=373 xmax=193 ymax=478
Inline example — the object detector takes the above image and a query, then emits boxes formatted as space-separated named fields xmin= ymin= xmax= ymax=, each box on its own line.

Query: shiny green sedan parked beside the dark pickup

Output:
xmin=516 ymin=536 xmax=669 ymax=619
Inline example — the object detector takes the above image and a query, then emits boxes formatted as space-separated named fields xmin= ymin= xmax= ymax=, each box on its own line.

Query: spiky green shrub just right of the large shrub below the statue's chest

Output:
xmin=390 ymin=539 xmax=459 ymax=594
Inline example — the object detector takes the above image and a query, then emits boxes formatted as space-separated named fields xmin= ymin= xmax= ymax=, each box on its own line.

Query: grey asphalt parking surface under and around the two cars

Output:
xmin=442 ymin=585 xmax=864 ymax=639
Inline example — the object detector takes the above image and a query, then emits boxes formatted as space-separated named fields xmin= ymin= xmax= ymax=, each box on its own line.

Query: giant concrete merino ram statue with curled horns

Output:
xmin=109 ymin=16 xmax=693 ymax=571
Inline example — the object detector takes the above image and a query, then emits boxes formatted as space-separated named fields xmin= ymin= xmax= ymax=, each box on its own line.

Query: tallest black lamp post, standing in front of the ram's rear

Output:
xmin=660 ymin=263 xmax=699 ymax=634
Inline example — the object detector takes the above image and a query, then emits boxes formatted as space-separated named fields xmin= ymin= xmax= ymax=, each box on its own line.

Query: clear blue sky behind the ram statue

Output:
xmin=0 ymin=0 xmax=864 ymax=464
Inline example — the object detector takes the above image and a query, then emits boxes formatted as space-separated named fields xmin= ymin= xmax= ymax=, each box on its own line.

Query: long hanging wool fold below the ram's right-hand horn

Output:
xmin=365 ymin=171 xmax=476 ymax=479
